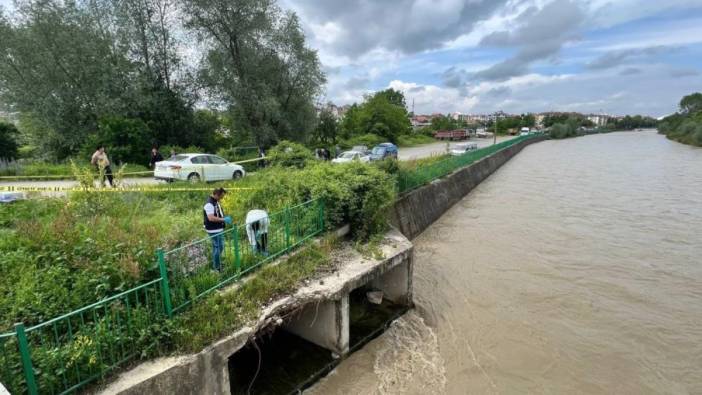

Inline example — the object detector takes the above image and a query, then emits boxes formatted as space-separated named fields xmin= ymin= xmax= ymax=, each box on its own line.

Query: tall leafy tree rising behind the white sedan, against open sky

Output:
xmin=184 ymin=0 xmax=325 ymax=146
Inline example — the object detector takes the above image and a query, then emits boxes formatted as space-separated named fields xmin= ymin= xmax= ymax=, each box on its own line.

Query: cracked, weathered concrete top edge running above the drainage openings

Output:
xmin=96 ymin=228 xmax=414 ymax=395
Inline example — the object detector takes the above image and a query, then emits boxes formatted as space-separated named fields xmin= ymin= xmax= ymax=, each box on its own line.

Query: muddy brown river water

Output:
xmin=308 ymin=132 xmax=702 ymax=394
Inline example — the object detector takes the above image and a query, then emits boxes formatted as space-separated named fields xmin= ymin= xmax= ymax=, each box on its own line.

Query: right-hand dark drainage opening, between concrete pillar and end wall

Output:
xmin=349 ymin=286 xmax=408 ymax=351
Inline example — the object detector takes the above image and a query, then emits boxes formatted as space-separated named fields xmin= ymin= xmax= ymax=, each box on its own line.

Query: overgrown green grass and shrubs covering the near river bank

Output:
xmin=0 ymin=157 xmax=396 ymax=392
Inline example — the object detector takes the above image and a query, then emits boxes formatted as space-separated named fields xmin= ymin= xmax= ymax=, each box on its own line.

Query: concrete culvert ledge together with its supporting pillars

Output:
xmin=99 ymin=230 xmax=413 ymax=395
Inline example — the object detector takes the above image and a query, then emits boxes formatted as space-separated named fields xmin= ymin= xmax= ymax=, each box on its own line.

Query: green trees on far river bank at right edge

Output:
xmin=658 ymin=93 xmax=702 ymax=147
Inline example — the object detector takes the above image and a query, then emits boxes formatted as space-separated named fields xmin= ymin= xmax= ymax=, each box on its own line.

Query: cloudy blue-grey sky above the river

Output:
xmin=279 ymin=0 xmax=702 ymax=116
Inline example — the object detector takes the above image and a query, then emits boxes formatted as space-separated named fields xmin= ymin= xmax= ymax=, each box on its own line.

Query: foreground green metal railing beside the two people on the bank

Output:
xmin=0 ymin=200 xmax=324 ymax=395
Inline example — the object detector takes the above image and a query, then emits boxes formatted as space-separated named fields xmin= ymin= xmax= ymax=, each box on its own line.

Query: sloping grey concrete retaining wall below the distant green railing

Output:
xmin=390 ymin=137 xmax=546 ymax=240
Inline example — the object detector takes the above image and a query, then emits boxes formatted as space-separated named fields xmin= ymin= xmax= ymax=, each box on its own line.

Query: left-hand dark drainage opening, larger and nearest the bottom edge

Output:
xmin=229 ymin=329 xmax=335 ymax=395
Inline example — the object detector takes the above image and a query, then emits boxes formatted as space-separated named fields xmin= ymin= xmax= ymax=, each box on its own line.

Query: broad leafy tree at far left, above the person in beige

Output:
xmin=0 ymin=1 xmax=130 ymax=157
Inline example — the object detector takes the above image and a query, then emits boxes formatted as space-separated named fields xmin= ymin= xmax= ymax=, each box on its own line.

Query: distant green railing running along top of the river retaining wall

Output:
xmin=397 ymin=134 xmax=540 ymax=193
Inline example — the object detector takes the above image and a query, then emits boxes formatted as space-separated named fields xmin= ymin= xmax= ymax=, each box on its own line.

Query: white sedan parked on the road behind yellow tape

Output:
xmin=154 ymin=154 xmax=246 ymax=182
